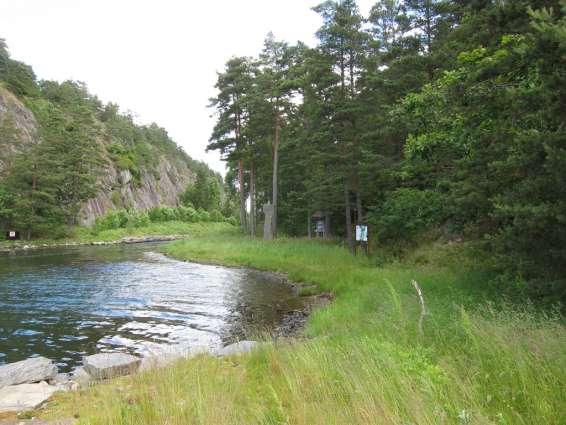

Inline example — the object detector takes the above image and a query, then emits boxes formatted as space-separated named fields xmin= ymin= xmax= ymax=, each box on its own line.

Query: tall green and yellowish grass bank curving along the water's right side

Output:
xmin=42 ymin=229 xmax=566 ymax=425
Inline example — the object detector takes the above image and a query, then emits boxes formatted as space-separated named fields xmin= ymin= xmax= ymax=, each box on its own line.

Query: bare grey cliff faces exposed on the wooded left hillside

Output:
xmin=0 ymin=83 xmax=203 ymax=225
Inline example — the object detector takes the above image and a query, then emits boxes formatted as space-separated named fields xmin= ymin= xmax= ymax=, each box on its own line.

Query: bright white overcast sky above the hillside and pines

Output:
xmin=0 ymin=0 xmax=375 ymax=174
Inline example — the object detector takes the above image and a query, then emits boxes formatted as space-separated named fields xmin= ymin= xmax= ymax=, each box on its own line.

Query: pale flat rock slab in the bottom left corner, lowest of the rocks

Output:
xmin=0 ymin=382 xmax=57 ymax=413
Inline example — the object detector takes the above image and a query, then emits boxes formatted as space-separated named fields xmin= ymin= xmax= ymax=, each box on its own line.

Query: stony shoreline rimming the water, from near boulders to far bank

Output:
xmin=0 ymin=242 xmax=332 ymax=424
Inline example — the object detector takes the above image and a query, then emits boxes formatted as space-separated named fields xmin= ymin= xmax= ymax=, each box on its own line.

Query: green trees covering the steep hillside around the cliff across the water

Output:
xmin=0 ymin=39 xmax=222 ymax=238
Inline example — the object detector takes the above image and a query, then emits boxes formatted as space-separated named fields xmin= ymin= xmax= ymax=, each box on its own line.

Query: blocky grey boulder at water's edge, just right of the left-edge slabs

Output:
xmin=83 ymin=353 xmax=141 ymax=379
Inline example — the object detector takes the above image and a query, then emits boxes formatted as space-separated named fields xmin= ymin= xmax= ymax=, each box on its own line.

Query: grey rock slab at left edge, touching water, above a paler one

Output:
xmin=0 ymin=357 xmax=57 ymax=388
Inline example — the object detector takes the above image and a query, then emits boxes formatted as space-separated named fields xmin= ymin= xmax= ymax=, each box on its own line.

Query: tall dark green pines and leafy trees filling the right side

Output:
xmin=208 ymin=0 xmax=566 ymax=291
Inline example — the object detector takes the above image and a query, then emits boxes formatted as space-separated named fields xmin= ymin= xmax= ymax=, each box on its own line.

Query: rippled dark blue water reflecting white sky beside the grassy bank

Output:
xmin=0 ymin=244 xmax=303 ymax=370
